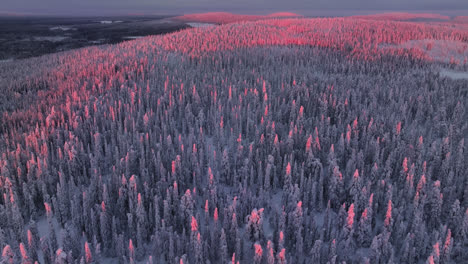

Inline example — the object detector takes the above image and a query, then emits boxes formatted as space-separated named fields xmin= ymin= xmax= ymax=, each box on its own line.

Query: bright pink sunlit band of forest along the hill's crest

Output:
xmin=146 ymin=18 xmax=466 ymax=63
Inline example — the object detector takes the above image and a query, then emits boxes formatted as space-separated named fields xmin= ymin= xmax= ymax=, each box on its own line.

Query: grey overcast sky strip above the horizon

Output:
xmin=0 ymin=0 xmax=468 ymax=15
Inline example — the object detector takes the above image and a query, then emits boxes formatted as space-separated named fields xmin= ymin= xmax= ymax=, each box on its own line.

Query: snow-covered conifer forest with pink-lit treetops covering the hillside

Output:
xmin=0 ymin=12 xmax=468 ymax=264
